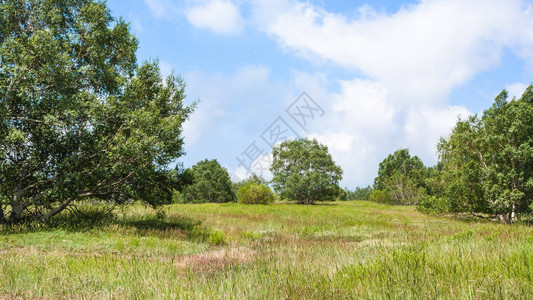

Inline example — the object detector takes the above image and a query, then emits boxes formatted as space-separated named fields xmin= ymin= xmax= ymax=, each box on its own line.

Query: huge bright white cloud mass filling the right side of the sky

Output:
xmin=247 ymin=0 xmax=533 ymax=185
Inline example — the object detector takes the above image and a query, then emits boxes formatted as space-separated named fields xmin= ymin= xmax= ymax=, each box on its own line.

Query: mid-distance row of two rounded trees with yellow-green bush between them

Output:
xmin=175 ymin=139 xmax=342 ymax=204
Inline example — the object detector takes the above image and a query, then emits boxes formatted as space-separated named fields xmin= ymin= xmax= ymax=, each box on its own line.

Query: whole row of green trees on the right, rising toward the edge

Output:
xmin=370 ymin=86 xmax=533 ymax=223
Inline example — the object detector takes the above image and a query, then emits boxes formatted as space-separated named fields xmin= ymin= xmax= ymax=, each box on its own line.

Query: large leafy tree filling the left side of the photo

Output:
xmin=0 ymin=0 xmax=192 ymax=222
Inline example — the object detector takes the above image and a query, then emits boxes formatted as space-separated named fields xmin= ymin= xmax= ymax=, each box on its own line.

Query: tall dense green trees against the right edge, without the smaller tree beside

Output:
xmin=439 ymin=86 xmax=533 ymax=222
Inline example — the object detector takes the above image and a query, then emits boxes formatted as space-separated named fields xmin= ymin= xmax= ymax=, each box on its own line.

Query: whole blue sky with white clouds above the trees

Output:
xmin=108 ymin=0 xmax=533 ymax=188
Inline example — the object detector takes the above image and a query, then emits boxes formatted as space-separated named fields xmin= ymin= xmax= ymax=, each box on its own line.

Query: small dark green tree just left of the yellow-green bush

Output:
xmin=182 ymin=159 xmax=235 ymax=203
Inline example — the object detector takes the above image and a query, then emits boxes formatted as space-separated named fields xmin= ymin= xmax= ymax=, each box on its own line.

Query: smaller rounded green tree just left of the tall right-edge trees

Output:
xmin=370 ymin=149 xmax=428 ymax=205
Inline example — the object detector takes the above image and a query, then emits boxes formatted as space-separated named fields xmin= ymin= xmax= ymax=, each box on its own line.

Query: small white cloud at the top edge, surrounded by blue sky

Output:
xmin=185 ymin=0 xmax=244 ymax=34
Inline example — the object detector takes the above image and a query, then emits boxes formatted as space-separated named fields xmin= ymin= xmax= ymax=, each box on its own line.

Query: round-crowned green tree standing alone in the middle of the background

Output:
xmin=270 ymin=139 xmax=342 ymax=204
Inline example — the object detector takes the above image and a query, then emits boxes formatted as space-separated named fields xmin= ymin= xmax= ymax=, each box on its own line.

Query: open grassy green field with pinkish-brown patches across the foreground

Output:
xmin=0 ymin=202 xmax=533 ymax=299
